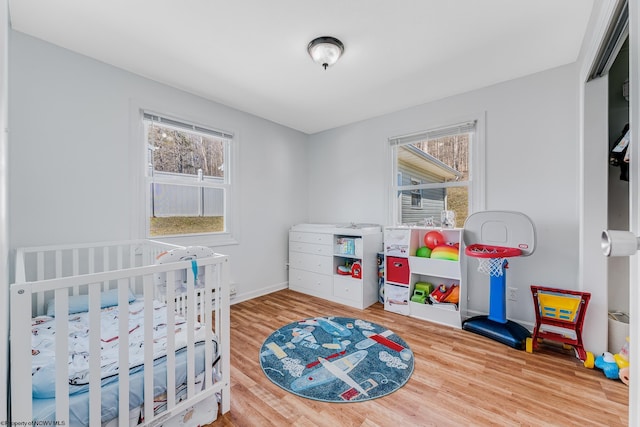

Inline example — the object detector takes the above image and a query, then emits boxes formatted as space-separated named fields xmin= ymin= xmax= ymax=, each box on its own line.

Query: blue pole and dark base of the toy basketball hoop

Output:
xmin=462 ymin=259 xmax=531 ymax=350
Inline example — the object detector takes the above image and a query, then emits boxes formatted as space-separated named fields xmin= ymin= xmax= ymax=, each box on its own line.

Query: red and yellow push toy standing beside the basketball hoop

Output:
xmin=526 ymin=285 xmax=594 ymax=368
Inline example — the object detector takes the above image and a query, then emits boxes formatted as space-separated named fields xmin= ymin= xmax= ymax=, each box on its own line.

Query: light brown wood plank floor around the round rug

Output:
xmin=211 ymin=290 xmax=628 ymax=427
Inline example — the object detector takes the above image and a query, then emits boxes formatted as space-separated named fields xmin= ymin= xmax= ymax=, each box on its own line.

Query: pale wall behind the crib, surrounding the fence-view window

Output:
xmin=9 ymin=31 xmax=308 ymax=299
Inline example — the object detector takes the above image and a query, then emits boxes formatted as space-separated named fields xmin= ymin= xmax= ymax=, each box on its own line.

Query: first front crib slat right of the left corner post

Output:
xmin=55 ymin=288 xmax=69 ymax=425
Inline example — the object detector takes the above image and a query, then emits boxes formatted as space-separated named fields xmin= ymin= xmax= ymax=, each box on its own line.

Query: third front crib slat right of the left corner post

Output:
xmin=118 ymin=279 xmax=129 ymax=426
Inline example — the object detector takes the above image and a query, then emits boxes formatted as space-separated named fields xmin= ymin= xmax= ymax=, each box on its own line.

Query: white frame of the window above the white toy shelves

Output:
xmin=387 ymin=112 xmax=486 ymax=228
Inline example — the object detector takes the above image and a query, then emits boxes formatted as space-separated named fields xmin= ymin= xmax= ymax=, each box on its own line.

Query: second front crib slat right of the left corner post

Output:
xmin=89 ymin=283 xmax=102 ymax=426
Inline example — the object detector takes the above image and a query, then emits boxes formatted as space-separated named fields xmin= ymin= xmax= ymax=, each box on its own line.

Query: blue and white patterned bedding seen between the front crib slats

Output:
xmin=31 ymin=299 xmax=218 ymax=425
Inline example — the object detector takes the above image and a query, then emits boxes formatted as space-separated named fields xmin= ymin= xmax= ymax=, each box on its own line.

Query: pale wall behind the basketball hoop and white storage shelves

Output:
xmin=309 ymin=65 xmax=580 ymax=336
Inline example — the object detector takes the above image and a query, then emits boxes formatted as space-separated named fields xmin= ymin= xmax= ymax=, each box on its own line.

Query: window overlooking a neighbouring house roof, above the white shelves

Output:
xmin=389 ymin=120 xmax=480 ymax=227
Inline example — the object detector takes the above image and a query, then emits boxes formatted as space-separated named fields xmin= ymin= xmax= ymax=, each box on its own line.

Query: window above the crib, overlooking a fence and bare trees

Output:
xmin=143 ymin=111 xmax=233 ymax=241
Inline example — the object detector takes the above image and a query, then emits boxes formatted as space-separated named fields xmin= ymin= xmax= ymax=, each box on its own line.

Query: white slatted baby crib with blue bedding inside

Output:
xmin=10 ymin=240 xmax=231 ymax=427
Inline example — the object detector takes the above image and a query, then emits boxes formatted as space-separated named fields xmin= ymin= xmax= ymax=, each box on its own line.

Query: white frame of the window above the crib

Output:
xmin=130 ymin=101 xmax=240 ymax=247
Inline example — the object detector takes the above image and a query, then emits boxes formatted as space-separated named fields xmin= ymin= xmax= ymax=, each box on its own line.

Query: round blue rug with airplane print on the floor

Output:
xmin=260 ymin=317 xmax=414 ymax=403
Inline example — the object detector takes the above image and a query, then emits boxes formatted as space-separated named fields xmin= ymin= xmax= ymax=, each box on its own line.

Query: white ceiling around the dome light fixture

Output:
xmin=9 ymin=0 xmax=596 ymax=134
